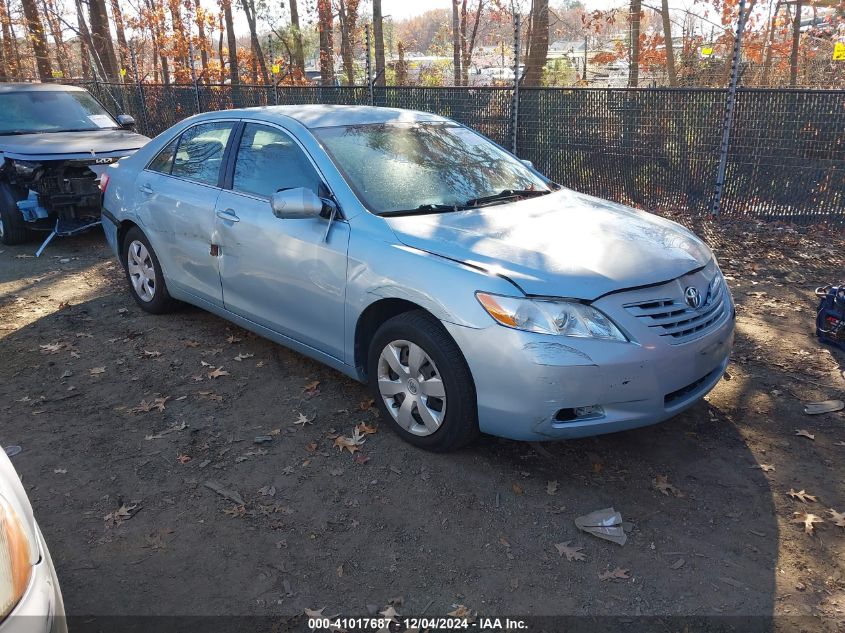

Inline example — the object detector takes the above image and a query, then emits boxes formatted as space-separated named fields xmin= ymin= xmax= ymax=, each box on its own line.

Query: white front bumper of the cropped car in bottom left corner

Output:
xmin=0 ymin=524 xmax=67 ymax=633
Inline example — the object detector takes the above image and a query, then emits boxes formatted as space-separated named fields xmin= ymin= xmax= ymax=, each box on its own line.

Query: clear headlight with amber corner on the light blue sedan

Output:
xmin=475 ymin=292 xmax=628 ymax=342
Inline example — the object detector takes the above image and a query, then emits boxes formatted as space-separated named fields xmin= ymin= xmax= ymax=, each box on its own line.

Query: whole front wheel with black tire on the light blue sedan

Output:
xmin=367 ymin=310 xmax=479 ymax=452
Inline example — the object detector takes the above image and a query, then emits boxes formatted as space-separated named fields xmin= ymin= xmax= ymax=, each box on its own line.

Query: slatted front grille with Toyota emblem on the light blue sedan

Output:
xmin=624 ymin=273 xmax=730 ymax=345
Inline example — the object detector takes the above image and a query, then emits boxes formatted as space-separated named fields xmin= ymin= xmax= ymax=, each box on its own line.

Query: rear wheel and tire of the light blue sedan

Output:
xmin=121 ymin=226 xmax=177 ymax=314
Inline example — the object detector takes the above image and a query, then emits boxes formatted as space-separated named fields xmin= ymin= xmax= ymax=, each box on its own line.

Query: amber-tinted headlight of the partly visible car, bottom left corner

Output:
xmin=0 ymin=497 xmax=32 ymax=619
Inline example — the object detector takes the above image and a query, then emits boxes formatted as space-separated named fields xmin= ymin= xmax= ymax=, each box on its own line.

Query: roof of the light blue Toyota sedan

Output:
xmin=203 ymin=105 xmax=449 ymax=129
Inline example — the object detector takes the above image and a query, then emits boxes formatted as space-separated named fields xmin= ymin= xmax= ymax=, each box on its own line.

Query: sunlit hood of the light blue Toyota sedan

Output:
xmin=385 ymin=189 xmax=713 ymax=301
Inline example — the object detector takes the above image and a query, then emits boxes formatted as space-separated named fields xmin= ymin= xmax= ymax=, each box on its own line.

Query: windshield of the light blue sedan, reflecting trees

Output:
xmin=314 ymin=123 xmax=554 ymax=215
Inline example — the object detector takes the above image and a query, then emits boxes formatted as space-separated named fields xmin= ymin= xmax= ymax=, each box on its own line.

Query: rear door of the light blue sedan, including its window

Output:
xmin=136 ymin=121 xmax=237 ymax=306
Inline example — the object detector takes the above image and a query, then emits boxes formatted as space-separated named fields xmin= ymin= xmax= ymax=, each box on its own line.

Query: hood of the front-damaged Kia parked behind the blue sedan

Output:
xmin=0 ymin=130 xmax=150 ymax=160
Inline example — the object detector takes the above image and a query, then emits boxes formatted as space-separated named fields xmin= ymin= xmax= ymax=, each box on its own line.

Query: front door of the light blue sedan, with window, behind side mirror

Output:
xmin=215 ymin=123 xmax=349 ymax=360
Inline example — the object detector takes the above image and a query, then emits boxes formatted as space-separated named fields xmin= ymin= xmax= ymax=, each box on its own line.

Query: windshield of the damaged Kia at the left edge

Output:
xmin=0 ymin=90 xmax=119 ymax=135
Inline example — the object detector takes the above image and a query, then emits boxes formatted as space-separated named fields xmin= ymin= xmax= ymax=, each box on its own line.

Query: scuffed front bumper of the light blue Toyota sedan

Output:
xmin=444 ymin=306 xmax=735 ymax=440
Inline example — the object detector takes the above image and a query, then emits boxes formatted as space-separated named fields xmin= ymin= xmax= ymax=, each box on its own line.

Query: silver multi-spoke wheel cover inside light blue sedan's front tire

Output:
xmin=378 ymin=340 xmax=446 ymax=436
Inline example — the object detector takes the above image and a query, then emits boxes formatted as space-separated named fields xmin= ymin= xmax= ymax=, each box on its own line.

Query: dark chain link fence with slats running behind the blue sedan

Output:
xmin=87 ymin=82 xmax=845 ymax=225
